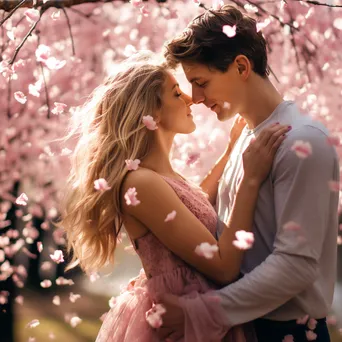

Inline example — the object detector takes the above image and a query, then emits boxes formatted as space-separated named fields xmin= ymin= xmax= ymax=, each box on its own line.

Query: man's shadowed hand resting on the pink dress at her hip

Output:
xmin=157 ymin=294 xmax=184 ymax=341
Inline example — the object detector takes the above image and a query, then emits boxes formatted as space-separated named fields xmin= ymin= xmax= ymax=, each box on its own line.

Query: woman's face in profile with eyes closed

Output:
xmin=158 ymin=72 xmax=196 ymax=134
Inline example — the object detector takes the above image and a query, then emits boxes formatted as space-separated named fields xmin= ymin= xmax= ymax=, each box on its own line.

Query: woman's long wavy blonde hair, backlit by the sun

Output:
xmin=56 ymin=58 xmax=166 ymax=273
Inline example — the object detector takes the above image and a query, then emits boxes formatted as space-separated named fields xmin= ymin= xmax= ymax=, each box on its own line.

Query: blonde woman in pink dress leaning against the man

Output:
xmin=59 ymin=54 xmax=288 ymax=342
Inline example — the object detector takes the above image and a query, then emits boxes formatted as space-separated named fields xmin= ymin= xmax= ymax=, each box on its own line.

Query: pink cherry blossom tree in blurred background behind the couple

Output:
xmin=0 ymin=0 xmax=342 ymax=341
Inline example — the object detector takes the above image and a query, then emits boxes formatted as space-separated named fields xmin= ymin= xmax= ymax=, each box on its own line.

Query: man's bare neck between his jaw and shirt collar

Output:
xmin=240 ymin=76 xmax=284 ymax=129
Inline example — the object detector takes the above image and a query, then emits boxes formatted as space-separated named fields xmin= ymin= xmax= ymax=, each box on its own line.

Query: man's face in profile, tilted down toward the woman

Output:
xmin=182 ymin=63 xmax=245 ymax=121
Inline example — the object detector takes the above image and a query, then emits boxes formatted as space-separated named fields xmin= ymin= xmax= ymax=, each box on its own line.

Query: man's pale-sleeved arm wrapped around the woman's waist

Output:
xmin=182 ymin=126 xmax=339 ymax=333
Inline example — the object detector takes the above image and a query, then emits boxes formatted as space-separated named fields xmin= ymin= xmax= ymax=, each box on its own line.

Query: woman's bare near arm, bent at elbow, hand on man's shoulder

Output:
xmin=122 ymin=124 xmax=285 ymax=284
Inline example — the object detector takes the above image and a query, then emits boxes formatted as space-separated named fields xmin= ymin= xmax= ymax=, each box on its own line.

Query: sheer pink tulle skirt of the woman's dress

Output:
xmin=96 ymin=267 xmax=249 ymax=342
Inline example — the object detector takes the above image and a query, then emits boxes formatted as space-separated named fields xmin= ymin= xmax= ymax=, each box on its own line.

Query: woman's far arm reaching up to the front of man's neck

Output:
xmin=200 ymin=115 xmax=246 ymax=205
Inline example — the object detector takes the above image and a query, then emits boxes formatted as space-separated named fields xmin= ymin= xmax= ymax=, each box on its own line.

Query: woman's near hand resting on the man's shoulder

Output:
xmin=242 ymin=124 xmax=291 ymax=185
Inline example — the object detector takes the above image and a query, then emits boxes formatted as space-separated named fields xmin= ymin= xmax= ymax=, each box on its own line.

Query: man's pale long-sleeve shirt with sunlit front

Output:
xmin=214 ymin=101 xmax=339 ymax=327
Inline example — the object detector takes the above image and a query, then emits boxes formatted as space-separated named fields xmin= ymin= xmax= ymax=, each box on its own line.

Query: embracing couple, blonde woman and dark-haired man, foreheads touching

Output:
xmin=59 ymin=5 xmax=339 ymax=342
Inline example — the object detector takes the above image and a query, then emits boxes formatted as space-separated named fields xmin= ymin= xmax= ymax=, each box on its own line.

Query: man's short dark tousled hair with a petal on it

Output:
xmin=165 ymin=5 xmax=269 ymax=77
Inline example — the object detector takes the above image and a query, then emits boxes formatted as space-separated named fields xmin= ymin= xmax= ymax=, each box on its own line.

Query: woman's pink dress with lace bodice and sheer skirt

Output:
xmin=96 ymin=177 xmax=245 ymax=342
